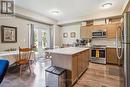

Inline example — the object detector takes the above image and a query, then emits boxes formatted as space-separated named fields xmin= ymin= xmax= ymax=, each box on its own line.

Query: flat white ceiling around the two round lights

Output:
xmin=15 ymin=0 xmax=127 ymax=21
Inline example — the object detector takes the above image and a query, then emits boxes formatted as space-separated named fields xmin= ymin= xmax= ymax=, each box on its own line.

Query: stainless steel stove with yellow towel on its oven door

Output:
xmin=90 ymin=45 xmax=106 ymax=64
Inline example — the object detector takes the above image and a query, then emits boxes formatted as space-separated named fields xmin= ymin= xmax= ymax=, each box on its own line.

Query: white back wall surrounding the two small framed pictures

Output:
xmin=61 ymin=23 xmax=81 ymax=44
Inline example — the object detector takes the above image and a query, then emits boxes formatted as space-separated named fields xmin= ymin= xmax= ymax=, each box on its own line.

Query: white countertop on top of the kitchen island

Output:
xmin=46 ymin=47 xmax=89 ymax=55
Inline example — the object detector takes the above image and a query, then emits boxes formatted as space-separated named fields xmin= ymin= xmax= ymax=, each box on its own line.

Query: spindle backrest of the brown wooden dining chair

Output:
xmin=18 ymin=47 xmax=32 ymax=61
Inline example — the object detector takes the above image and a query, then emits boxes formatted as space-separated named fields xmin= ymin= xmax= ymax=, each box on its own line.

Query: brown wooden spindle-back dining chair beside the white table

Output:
xmin=16 ymin=47 xmax=32 ymax=77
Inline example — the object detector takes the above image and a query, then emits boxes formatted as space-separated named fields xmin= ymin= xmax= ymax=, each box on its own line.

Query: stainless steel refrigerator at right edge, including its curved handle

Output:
xmin=116 ymin=13 xmax=130 ymax=87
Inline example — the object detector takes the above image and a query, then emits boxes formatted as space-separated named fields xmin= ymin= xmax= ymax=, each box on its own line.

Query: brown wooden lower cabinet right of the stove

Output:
xmin=107 ymin=48 xmax=118 ymax=64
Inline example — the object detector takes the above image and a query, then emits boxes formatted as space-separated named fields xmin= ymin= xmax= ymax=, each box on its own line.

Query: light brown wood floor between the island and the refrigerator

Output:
xmin=74 ymin=63 xmax=123 ymax=87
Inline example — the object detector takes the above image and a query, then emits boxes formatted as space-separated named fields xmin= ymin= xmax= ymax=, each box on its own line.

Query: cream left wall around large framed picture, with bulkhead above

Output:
xmin=0 ymin=6 xmax=57 ymax=51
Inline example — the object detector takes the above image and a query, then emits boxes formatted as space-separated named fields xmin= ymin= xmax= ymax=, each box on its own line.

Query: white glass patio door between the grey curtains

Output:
xmin=34 ymin=28 xmax=50 ymax=57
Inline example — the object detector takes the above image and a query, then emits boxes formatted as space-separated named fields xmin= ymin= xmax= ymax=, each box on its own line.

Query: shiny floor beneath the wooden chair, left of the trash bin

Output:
xmin=0 ymin=59 xmax=51 ymax=87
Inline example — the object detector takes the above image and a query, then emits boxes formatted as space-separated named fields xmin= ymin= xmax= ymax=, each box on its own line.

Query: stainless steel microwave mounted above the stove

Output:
xmin=92 ymin=30 xmax=106 ymax=38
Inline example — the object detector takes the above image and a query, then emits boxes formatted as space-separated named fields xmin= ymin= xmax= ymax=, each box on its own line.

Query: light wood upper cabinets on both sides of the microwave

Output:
xmin=80 ymin=17 xmax=121 ymax=38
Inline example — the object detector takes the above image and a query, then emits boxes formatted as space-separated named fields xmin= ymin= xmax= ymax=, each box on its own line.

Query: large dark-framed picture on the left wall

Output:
xmin=1 ymin=25 xmax=17 ymax=43
